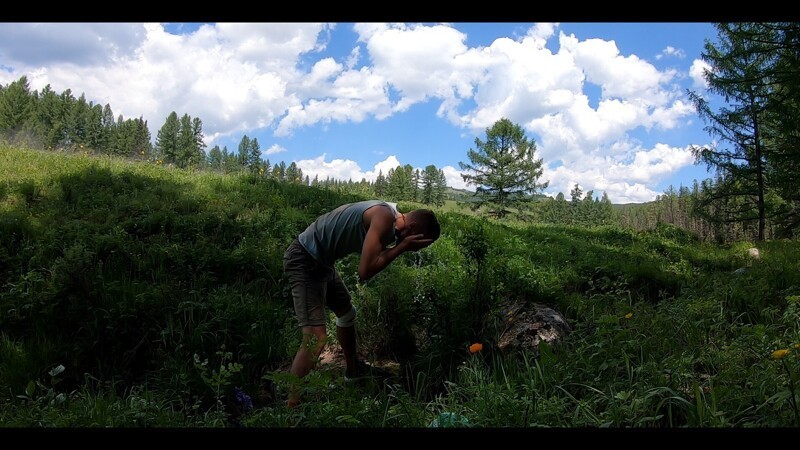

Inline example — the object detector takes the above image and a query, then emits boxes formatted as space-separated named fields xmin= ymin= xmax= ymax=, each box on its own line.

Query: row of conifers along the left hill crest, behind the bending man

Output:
xmin=0 ymin=76 xmax=447 ymax=205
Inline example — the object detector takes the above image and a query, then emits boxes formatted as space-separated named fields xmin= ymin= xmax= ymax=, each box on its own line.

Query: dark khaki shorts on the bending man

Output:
xmin=283 ymin=239 xmax=350 ymax=327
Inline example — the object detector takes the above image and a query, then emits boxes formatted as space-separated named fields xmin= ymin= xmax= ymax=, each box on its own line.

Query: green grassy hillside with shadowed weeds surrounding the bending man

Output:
xmin=0 ymin=147 xmax=800 ymax=427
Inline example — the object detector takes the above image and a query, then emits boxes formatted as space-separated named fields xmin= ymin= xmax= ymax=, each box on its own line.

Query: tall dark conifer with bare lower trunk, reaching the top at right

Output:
xmin=689 ymin=23 xmax=776 ymax=241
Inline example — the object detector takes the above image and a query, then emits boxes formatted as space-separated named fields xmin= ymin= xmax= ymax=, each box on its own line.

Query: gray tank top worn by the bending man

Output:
xmin=297 ymin=200 xmax=397 ymax=267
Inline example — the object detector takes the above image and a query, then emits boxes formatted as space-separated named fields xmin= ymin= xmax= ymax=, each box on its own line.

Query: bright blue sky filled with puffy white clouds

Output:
xmin=0 ymin=22 xmax=716 ymax=203
